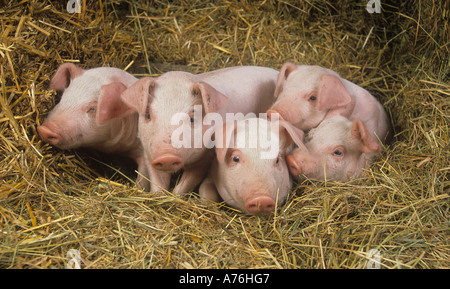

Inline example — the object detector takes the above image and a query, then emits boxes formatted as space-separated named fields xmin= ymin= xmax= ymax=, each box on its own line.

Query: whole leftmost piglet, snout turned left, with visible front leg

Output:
xmin=37 ymin=63 xmax=149 ymax=188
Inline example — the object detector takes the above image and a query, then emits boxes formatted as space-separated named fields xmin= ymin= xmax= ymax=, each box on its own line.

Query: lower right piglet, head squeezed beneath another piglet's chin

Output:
xmin=286 ymin=116 xmax=381 ymax=181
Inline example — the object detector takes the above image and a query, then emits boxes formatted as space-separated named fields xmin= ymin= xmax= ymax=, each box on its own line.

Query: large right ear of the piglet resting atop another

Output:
xmin=317 ymin=74 xmax=352 ymax=110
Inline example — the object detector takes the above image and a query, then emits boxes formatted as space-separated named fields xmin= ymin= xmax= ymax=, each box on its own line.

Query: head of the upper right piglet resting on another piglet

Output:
xmin=267 ymin=62 xmax=352 ymax=130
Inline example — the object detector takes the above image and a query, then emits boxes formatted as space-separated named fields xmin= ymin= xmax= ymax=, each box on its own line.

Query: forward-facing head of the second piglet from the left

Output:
xmin=122 ymin=72 xmax=227 ymax=172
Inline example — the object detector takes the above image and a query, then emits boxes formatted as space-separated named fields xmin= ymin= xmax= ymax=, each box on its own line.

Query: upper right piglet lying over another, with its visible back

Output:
xmin=267 ymin=62 xmax=389 ymax=143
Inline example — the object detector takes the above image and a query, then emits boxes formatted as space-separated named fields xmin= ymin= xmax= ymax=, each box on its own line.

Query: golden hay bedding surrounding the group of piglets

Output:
xmin=0 ymin=0 xmax=450 ymax=268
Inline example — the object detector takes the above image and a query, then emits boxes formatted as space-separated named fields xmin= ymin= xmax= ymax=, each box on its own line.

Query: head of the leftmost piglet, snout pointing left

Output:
xmin=37 ymin=63 xmax=135 ymax=150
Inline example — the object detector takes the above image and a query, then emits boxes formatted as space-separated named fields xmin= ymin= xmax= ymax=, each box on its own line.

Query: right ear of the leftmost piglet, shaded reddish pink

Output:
xmin=97 ymin=82 xmax=134 ymax=124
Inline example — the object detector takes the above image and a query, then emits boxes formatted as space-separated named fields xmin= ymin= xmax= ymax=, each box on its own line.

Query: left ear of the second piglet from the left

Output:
xmin=120 ymin=77 xmax=156 ymax=114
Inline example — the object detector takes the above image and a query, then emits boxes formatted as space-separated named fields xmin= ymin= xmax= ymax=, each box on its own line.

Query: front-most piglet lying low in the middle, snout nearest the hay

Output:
xmin=199 ymin=118 xmax=303 ymax=215
